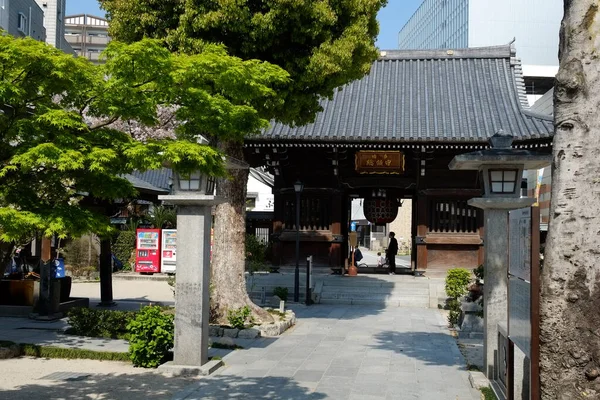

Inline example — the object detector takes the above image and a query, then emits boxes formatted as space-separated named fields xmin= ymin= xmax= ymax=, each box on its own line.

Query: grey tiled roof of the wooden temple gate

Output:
xmin=253 ymin=45 xmax=553 ymax=143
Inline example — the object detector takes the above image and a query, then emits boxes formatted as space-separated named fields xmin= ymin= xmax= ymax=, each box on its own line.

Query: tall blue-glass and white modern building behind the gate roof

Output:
xmin=398 ymin=0 xmax=563 ymax=104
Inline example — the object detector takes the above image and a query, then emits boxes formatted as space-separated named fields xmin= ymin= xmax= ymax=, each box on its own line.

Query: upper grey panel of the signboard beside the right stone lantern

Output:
xmin=508 ymin=208 xmax=531 ymax=282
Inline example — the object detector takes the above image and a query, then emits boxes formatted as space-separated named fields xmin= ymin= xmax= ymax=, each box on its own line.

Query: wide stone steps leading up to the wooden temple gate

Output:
xmin=247 ymin=272 xmax=444 ymax=308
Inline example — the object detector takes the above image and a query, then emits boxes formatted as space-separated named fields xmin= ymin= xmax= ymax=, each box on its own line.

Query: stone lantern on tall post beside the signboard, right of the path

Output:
xmin=449 ymin=131 xmax=552 ymax=380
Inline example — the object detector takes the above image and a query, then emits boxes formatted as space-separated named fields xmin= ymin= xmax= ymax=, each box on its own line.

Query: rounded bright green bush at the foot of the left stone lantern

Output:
xmin=127 ymin=306 xmax=175 ymax=368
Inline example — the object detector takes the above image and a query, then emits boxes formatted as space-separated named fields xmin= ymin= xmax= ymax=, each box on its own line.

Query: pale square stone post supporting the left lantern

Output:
xmin=173 ymin=205 xmax=211 ymax=366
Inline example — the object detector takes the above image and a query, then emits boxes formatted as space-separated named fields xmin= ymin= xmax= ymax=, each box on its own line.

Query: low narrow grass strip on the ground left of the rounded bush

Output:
xmin=0 ymin=341 xmax=130 ymax=362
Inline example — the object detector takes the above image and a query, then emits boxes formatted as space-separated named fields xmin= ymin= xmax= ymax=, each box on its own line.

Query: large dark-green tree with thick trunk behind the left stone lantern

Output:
xmin=100 ymin=0 xmax=386 ymax=321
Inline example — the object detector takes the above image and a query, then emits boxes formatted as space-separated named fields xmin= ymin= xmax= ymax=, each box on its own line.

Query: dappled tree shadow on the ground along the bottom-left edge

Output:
xmin=0 ymin=371 xmax=325 ymax=400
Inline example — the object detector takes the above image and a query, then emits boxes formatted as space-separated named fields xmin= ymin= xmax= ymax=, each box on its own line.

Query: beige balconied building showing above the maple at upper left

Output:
xmin=64 ymin=14 xmax=110 ymax=63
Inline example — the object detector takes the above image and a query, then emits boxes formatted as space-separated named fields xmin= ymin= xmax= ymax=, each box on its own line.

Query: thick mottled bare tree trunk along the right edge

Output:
xmin=540 ymin=0 xmax=600 ymax=400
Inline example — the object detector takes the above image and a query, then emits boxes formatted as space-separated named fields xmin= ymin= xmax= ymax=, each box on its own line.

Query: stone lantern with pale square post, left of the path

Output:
xmin=158 ymin=158 xmax=248 ymax=375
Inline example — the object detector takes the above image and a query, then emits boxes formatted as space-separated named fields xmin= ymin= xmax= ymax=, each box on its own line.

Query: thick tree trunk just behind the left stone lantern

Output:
xmin=211 ymin=143 xmax=273 ymax=323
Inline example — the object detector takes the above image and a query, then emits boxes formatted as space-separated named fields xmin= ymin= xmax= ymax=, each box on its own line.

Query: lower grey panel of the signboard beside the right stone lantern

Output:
xmin=508 ymin=276 xmax=531 ymax=357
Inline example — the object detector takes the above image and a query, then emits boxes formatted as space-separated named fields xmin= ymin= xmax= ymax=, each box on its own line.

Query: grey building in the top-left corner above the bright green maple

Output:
xmin=0 ymin=0 xmax=46 ymax=41
